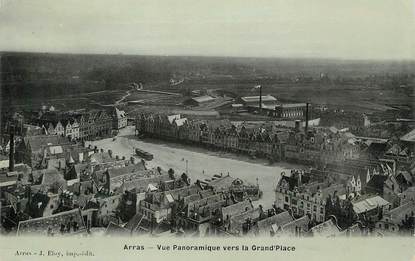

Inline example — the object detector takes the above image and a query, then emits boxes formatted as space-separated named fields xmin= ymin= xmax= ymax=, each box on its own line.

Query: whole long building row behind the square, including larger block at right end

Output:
xmin=136 ymin=111 xmax=374 ymax=164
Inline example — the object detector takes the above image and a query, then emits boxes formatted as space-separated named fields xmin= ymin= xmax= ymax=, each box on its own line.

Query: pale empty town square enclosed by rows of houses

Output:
xmin=88 ymin=128 xmax=302 ymax=207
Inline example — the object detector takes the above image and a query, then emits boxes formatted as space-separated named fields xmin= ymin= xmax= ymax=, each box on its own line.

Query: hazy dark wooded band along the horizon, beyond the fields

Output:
xmin=0 ymin=53 xmax=415 ymax=99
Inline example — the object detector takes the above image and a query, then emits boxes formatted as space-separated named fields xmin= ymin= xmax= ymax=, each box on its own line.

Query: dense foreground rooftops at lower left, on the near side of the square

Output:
xmin=0 ymin=120 xmax=270 ymax=236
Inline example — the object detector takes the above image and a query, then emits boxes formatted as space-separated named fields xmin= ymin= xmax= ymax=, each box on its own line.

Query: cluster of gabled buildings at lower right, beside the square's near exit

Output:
xmin=275 ymin=155 xmax=415 ymax=237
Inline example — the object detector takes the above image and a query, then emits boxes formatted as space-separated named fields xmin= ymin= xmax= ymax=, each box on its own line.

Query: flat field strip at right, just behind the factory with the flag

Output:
xmin=172 ymin=80 xmax=414 ymax=112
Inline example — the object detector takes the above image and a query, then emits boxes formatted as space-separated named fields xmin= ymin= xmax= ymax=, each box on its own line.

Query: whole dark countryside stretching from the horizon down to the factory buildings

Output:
xmin=0 ymin=53 xmax=415 ymax=115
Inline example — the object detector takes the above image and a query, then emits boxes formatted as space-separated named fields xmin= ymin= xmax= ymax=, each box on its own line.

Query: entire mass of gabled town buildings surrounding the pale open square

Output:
xmin=0 ymin=101 xmax=415 ymax=237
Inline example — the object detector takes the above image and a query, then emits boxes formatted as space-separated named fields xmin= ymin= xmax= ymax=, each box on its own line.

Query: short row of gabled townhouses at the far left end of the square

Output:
xmin=35 ymin=110 xmax=113 ymax=140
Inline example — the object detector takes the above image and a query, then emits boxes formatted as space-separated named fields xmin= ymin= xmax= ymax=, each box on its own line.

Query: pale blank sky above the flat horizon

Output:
xmin=0 ymin=0 xmax=415 ymax=59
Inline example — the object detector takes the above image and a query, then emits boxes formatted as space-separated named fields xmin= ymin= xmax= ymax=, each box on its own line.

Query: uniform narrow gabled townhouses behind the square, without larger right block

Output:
xmin=135 ymin=114 xmax=283 ymax=159
